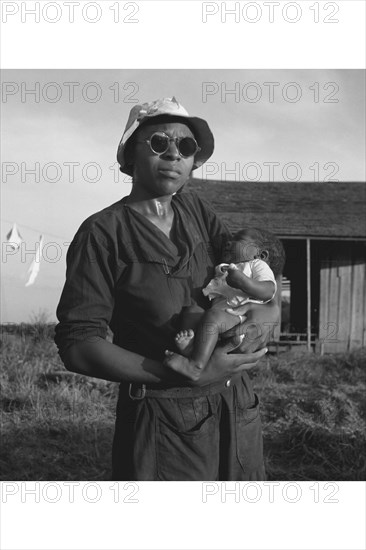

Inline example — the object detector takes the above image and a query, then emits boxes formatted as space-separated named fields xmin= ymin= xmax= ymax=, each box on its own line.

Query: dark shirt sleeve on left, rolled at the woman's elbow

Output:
xmin=55 ymin=229 xmax=115 ymax=358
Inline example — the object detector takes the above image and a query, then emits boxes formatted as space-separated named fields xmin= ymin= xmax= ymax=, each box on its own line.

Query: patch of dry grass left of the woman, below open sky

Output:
xmin=0 ymin=338 xmax=118 ymax=480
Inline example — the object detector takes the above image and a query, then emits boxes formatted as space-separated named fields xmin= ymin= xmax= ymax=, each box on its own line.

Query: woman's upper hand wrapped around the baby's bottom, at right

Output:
xmin=222 ymin=301 xmax=280 ymax=354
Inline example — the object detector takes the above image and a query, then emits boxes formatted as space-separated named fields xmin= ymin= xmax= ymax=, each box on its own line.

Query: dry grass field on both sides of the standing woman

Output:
xmin=0 ymin=329 xmax=366 ymax=481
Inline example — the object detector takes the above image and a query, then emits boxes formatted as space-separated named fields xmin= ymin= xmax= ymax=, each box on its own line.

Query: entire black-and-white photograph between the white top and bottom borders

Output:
xmin=1 ymin=70 xmax=366 ymax=481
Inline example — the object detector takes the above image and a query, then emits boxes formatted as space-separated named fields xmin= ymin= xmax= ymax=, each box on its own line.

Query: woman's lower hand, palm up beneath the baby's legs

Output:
xmin=192 ymin=338 xmax=267 ymax=386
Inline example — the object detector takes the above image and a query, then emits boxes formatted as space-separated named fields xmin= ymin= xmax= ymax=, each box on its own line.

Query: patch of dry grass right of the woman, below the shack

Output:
xmin=254 ymin=350 xmax=366 ymax=481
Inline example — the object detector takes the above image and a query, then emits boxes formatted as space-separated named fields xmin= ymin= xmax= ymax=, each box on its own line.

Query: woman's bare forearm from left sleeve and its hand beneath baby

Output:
xmin=61 ymin=338 xmax=266 ymax=385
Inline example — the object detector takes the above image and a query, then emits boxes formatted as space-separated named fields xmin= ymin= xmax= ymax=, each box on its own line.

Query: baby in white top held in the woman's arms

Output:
xmin=164 ymin=228 xmax=285 ymax=380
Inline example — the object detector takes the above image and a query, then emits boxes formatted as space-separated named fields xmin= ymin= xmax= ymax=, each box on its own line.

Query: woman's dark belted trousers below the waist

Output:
xmin=113 ymin=373 xmax=265 ymax=481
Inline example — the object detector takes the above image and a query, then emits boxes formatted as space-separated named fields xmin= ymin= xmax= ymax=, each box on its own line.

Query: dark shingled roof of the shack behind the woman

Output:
xmin=188 ymin=178 xmax=366 ymax=239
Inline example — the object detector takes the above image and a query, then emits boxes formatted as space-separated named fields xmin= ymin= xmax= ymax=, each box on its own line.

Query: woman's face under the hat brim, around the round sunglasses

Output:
xmin=133 ymin=122 xmax=194 ymax=198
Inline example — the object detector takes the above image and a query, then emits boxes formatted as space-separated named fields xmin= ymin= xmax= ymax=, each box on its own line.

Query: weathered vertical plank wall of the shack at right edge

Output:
xmin=319 ymin=242 xmax=366 ymax=353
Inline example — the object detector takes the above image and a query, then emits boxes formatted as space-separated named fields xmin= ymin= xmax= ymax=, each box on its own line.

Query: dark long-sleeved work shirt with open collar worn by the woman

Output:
xmin=55 ymin=192 xmax=230 ymax=361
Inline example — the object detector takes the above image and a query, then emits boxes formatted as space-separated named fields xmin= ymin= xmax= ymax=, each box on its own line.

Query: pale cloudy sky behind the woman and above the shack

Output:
xmin=1 ymin=69 xmax=366 ymax=322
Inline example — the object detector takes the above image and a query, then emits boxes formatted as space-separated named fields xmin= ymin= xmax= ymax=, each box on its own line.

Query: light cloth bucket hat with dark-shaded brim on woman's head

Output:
xmin=117 ymin=97 xmax=214 ymax=176
